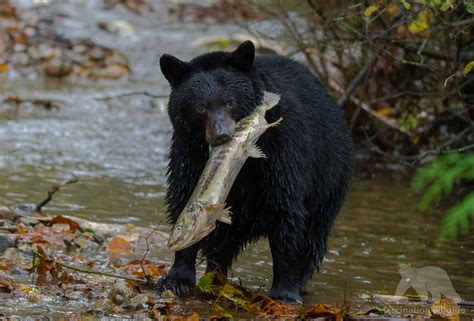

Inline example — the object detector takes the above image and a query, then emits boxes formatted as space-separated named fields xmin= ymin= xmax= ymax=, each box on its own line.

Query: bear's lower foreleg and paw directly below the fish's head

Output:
xmin=158 ymin=243 xmax=200 ymax=296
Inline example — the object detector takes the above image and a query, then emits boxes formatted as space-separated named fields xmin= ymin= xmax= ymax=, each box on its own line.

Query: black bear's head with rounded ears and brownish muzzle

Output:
xmin=160 ymin=41 xmax=262 ymax=146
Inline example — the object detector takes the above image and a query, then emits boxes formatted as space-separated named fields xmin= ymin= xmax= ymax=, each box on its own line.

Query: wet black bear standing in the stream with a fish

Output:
xmin=159 ymin=41 xmax=353 ymax=303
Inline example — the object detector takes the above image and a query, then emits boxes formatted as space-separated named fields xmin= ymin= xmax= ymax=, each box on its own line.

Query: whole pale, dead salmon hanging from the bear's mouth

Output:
xmin=168 ymin=92 xmax=282 ymax=251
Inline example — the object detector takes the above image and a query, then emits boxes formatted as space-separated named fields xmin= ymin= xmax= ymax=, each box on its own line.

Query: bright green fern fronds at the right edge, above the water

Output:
xmin=413 ymin=153 xmax=474 ymax=242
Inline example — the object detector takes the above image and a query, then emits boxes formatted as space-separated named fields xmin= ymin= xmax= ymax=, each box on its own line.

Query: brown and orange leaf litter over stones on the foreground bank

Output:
xmin=0 ymin=184 xmax=460 ymax=321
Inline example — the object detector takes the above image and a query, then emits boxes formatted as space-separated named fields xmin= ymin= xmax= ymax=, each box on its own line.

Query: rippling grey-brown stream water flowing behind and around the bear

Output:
xmin=0 ymin=1 xmax=474 ymax=316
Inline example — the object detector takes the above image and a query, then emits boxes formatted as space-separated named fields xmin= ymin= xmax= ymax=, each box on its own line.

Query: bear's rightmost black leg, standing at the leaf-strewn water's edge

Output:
xmin=269 ymin=220 xmax=306 ymax=304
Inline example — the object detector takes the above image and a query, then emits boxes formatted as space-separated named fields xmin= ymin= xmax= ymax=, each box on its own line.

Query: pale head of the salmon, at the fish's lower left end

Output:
xmin=168 ymin=202 xmax=215 ymax=251
